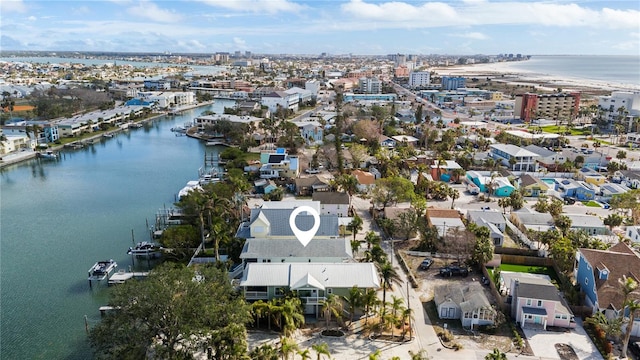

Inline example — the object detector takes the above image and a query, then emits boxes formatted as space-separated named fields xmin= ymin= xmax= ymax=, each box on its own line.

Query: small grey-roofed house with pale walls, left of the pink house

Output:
xmin=433 ymin=283 xmax=496 ymax=329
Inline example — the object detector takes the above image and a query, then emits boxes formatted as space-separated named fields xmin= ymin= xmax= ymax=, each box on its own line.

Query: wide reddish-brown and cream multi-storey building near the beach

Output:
xmin=514 ymin=92 xmax=580 ymax=122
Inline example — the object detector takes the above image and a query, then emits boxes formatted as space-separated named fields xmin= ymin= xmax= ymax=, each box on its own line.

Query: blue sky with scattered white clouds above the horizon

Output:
xmin=0 ymin=0 xmax=640 ymax=55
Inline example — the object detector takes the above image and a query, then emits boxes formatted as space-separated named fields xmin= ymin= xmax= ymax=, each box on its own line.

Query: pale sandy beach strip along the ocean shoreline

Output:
xmin=432 ymin=61 xmax=640 ymax=92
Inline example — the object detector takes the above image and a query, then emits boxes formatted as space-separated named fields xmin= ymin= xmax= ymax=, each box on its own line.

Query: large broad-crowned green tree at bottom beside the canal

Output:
xmin=89 ymin=264 xmax=251 ymax=359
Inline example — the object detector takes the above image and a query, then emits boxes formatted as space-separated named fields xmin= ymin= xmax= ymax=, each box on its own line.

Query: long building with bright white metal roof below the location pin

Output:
xmin=240 ymin=262 xmax=380 ymax=317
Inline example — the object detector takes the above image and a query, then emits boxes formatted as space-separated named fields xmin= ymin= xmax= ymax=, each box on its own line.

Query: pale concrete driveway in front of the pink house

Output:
xmin=523 ymin=319 xmax=603 ymax=360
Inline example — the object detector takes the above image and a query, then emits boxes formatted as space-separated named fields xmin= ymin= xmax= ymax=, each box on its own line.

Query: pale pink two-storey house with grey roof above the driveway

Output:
xmin=509 ymin=277 xmax=576 ymax=330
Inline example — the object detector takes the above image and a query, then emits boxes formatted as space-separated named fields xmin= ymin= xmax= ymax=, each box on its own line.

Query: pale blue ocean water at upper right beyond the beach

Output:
xmin=498 ymin=55 xmax=640 ymax=86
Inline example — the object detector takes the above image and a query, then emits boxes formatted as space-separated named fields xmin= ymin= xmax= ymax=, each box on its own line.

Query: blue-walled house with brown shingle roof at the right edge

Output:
xmin=574 ymin=242 xmax=640 ymax=336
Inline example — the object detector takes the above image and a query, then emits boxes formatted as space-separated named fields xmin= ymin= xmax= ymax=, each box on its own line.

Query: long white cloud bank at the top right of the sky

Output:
xmin=341 ymin=0 xmax=640 ymax=29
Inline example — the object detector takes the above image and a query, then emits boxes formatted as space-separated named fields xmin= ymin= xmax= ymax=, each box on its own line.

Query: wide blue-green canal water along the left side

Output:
xmin=0 ymin=101 xmax=233 ymax=360
